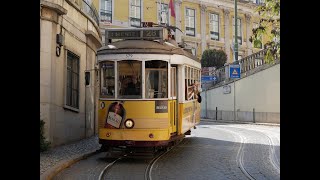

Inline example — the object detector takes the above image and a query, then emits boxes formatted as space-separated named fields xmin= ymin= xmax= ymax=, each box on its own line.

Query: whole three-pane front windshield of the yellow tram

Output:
xmin=100 ymin=60 xmax=168 ymax=99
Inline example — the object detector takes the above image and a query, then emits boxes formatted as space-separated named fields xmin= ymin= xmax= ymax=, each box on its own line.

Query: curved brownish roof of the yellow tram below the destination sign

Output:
xmin=98 ymin=40 xmax=199 ymax=62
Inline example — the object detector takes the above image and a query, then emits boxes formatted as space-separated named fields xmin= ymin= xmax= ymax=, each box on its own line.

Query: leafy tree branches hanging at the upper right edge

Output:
xmin=249 ymin=0 xmax=280 ymax=63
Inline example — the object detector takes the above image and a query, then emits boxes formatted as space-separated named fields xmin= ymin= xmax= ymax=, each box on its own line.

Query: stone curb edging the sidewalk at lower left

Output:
xmin=40 ymin=149 xmax=99 ymax=180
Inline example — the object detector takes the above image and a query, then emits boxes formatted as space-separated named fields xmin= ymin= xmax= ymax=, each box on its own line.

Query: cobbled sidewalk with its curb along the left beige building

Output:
xmin=40 ymin=136 xmax=101 ymax=180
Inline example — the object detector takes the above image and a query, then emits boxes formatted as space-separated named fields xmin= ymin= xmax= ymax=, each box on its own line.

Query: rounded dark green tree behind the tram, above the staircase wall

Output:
xmin=201 ymin=49 xmax=227 ymax=69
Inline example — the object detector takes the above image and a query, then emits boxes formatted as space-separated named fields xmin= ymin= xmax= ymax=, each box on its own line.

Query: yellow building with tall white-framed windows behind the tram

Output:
xmin=97 ymin=0 xmax=260 ymax=62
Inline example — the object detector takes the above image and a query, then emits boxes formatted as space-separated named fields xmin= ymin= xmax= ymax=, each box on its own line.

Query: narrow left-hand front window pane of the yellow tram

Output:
xmin=100 ymin=62 xmax=115 ymax=98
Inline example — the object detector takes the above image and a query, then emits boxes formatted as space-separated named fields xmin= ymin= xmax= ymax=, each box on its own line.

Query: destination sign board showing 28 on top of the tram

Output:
xmin=105 ymin=27 xmax=163 ymax=39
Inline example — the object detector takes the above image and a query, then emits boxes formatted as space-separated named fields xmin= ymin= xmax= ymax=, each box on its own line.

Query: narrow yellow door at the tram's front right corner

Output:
xmin=170 ymin=65 xmax=178 ymax=132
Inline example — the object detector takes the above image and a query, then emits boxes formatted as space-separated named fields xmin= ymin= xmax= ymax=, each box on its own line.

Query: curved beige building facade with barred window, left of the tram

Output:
xmin=40 ymin=0 xmax=102 ymax=146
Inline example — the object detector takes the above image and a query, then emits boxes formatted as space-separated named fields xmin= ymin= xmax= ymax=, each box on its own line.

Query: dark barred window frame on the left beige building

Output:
xmin=64 ymin=49 xmax=80 ymax=112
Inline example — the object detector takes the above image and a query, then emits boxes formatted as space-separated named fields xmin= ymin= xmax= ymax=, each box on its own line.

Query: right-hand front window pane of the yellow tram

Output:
xmin=145 ymin=60 xmax=168 ymax=99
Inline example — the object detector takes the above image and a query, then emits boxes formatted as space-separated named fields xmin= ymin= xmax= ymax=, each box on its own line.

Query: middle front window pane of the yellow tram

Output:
xmin=118 ymin=60 xmax=142 ymax=99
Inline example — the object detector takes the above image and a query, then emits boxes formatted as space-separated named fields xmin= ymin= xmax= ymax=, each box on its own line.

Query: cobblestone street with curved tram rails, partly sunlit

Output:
xmin=48 ymin=122 xmax=280 ymax=180
